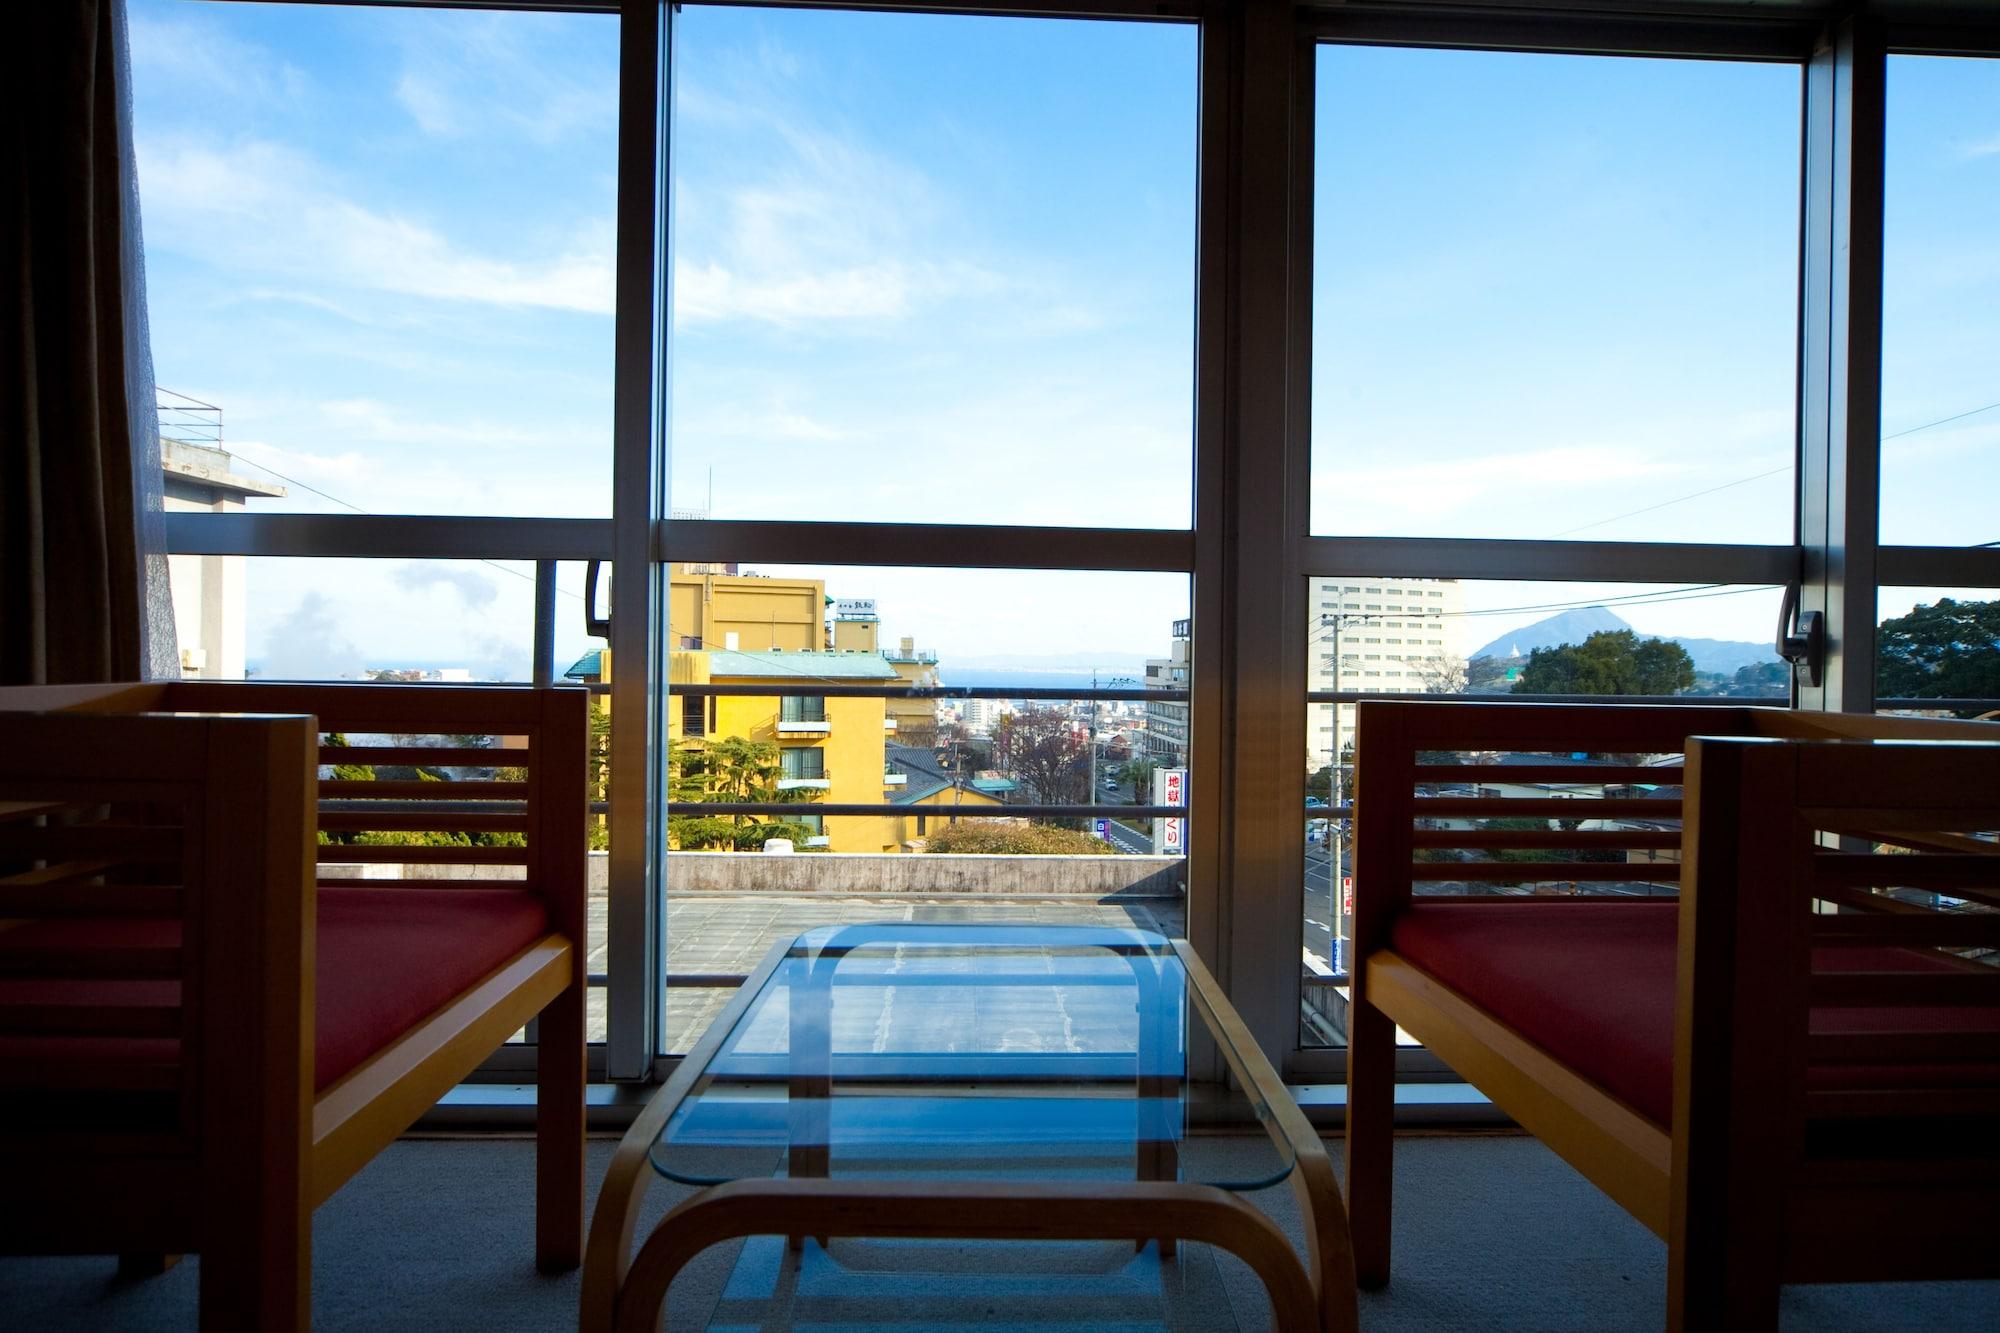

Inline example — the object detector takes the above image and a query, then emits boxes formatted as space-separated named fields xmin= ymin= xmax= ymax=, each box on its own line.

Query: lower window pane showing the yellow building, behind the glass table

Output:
xmin=662 ymin=556 xmax=1188 ymax=1051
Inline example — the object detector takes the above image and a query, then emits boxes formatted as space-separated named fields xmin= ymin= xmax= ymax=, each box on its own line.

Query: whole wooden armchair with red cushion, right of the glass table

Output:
xmin=1348 ymin=703 xmax=2000 ymax=1329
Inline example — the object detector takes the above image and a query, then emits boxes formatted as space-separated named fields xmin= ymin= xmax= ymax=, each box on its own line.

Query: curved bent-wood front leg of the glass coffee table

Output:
xmin=616 ymin=1181 xmax=1324 ymax=1333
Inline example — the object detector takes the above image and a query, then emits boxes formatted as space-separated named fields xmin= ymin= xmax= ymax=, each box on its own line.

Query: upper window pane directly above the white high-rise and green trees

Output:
xmin=1312 ymin=46 xmax=1800 ymax=542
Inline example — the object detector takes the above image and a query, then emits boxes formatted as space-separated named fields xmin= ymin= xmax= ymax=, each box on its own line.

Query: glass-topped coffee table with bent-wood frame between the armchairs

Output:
xmin=582 ymin=923 xmax=1354 ymax=1333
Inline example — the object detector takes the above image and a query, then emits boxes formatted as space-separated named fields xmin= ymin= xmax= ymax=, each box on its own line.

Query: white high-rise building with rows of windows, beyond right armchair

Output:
xmin=1306 ymin=578 xmax=1466 ymax=773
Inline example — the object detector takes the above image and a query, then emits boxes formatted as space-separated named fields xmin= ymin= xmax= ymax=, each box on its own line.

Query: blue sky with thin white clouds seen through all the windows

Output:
xmin=130 ymin=0 xmax=2000 ymax=667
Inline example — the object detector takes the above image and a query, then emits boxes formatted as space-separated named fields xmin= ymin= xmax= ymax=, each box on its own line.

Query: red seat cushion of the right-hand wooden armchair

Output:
xmin=1390 ymin=899 xmax=2000 ymax=1125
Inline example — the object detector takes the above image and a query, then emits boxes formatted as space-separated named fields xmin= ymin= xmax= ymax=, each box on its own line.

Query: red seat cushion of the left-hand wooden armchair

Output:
xmin=0 ymin=887 xmax=548 ymax=1091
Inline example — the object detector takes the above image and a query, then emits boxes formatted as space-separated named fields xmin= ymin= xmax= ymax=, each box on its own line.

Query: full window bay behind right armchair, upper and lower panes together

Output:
xmin=1300 ymin=44 xmax=1802 ymax=1047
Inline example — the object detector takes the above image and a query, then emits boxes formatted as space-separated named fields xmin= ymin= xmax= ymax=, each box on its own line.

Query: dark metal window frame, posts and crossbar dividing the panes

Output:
xmin=166 ymin=0 xmax=2000 ymax=1079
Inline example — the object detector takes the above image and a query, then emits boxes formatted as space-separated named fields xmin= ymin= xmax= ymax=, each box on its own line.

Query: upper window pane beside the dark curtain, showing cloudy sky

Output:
xmin=130 ymin=0 xmax=618 ymax=520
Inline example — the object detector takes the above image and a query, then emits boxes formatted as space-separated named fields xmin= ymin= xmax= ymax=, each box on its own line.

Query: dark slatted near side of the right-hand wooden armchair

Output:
xmin=1668 ymin=739 xmax=2000 ymax=1304
